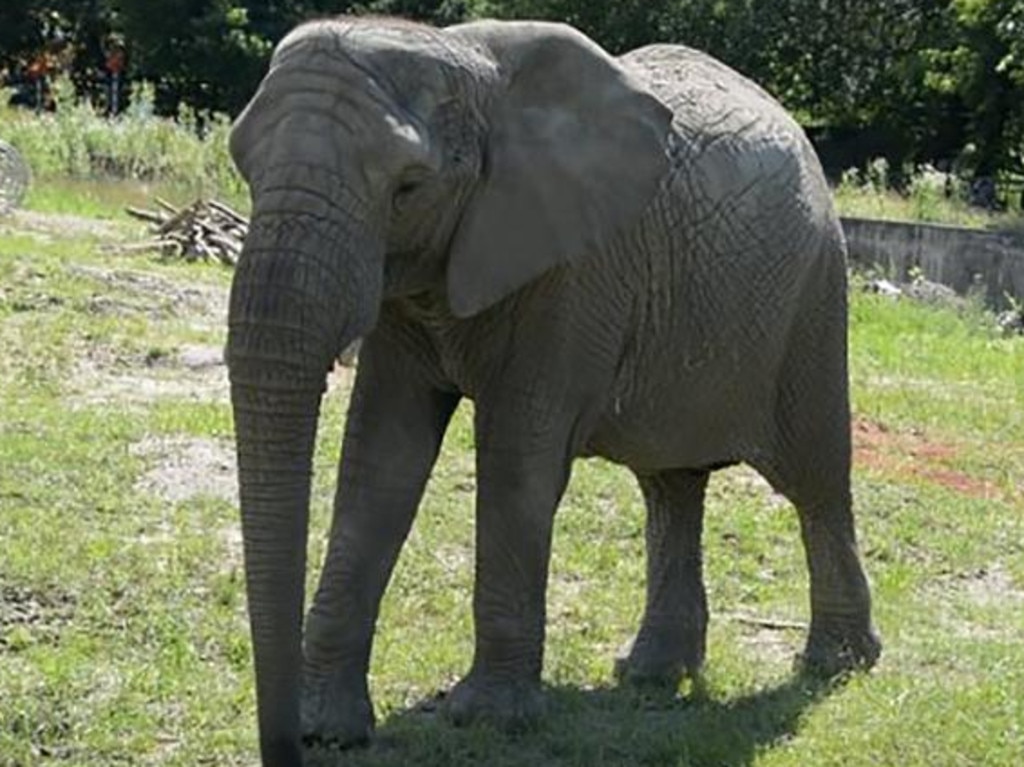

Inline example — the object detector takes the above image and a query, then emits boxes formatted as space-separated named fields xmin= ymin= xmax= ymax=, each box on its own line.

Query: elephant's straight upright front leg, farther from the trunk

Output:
xmin=446 ymin=406 xmax=570 ymax=730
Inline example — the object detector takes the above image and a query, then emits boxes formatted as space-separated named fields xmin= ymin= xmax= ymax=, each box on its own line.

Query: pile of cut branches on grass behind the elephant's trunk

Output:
xmin=124 ymin=197 xmax=249 ymax=266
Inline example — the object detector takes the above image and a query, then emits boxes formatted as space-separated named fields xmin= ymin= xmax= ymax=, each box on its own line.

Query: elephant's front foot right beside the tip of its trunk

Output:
xmin=302 ymin=672 xmax=374 ymax=750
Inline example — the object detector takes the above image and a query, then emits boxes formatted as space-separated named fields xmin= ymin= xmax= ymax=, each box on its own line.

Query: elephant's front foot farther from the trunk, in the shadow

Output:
xmin=443 ymin=672 xmax=545 ymax=732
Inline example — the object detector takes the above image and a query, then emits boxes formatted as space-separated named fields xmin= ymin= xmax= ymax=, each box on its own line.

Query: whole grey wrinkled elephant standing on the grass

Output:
xmin=226 ymin=16 xmax=881 ymax=765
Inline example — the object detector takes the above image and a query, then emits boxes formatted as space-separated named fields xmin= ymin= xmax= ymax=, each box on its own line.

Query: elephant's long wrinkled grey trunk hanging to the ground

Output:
xmin=227 ymin=188 xmax=381 ymax=765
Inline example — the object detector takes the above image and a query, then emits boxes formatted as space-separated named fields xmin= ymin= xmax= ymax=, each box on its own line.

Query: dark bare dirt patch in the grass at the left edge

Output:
xmin=0 ymin=578 xmax=75 ymax=653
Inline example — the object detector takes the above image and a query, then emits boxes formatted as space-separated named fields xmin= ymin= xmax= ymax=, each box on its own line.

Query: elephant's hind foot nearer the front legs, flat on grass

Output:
xmin=615 ymin=629 xmax=705 ymax=693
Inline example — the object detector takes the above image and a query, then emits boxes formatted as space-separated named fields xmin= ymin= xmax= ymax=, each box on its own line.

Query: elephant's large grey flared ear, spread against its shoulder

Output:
xmin=447 ymin=22 xmax=672 ymax=316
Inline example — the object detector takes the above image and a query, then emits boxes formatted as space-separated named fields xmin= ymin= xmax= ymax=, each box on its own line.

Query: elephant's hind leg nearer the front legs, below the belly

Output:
xmin=616 ymin=462 xmax=709 ymax=690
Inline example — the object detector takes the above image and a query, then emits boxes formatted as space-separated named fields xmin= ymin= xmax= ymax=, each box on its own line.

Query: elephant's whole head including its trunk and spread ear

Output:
xmin=227 ymin=19 xmax=671 ymax=763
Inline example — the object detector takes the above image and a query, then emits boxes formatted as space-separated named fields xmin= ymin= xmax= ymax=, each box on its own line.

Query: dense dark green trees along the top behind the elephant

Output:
xmin=0 ymin=0 xmax=1024 ymax=176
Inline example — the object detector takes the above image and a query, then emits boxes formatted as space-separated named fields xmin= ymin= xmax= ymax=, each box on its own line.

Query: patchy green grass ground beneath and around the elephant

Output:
xmin=0 ymin=206 xmax=1024 ymax=767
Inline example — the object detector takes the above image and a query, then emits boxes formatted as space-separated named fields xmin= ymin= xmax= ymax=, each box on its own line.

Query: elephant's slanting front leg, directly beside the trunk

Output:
xmin=302 ymin=337 xmax=459 ymax=747
